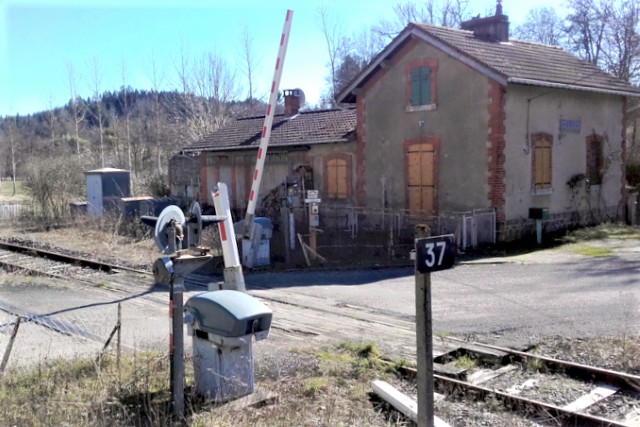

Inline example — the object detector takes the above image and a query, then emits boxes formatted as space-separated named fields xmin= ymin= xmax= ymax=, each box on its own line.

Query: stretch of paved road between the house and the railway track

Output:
xmin=246 ymin=242 xmax=640 ymax=346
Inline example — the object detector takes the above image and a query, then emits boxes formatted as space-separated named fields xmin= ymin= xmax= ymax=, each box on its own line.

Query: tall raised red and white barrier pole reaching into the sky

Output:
xmin=242 ymin=10 xmax=293 ymax=267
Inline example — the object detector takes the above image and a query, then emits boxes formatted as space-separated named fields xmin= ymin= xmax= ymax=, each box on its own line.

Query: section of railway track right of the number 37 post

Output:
xmin=401 ymin=338 xmax=640 ymax=427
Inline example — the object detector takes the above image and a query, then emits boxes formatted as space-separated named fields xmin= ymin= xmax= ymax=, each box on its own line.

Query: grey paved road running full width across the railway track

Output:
xmin=0 ymin=237 xmax=640 ymax=366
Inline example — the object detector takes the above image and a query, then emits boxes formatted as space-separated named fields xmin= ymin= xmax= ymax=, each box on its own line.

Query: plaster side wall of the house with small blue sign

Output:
xmin=505 ymin=85 xmax=623 ymax=220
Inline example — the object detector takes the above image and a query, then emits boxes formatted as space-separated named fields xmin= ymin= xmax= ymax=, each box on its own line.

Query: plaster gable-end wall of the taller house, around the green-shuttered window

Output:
xmin=358 ymin=41 xmax=490 ymax=212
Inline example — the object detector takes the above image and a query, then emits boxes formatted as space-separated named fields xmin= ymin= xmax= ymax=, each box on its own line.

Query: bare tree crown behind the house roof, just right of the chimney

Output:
xmin=514 ymin=6 xmax=565 ymax=46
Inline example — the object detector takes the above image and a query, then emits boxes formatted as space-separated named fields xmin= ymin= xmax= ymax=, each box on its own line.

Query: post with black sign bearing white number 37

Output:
xmin=415 ymin=231 xmax=456 ymax=427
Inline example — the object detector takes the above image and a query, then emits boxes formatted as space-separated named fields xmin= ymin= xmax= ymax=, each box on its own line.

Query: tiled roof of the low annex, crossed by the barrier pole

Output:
xmin=182 ymin=108 xmax=356 ymax=152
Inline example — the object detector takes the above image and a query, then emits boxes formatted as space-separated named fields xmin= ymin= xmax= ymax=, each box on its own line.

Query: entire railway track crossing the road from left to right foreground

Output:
xmin=0 ymin=241 xmax=640 ymax=427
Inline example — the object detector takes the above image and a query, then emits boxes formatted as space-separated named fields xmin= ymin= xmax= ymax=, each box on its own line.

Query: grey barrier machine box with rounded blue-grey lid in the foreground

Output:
xmin=185 ymin=290 xmax=273 ymax=402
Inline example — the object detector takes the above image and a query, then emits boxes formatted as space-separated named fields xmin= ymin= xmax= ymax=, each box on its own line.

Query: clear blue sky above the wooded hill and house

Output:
xmin=0 ymin=0 xmax=558 ymax=116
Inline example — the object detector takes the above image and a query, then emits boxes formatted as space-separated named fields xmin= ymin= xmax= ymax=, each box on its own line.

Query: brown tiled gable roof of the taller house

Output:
xmin=338 ymin=23 xmax=640 ymax=102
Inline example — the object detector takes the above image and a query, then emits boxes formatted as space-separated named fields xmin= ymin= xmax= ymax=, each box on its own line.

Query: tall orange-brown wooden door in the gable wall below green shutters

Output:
xmin=407 ymin=143 xmax=435 ymax=215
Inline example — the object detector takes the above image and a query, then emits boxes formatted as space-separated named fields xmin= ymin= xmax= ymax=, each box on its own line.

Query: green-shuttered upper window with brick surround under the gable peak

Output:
xmin=405 ymin=59 xmax=438 ymax=111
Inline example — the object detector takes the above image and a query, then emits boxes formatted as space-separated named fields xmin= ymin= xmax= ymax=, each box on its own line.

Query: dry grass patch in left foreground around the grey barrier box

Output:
xmin=0 ymin=343 xmax=403 ymax=427
